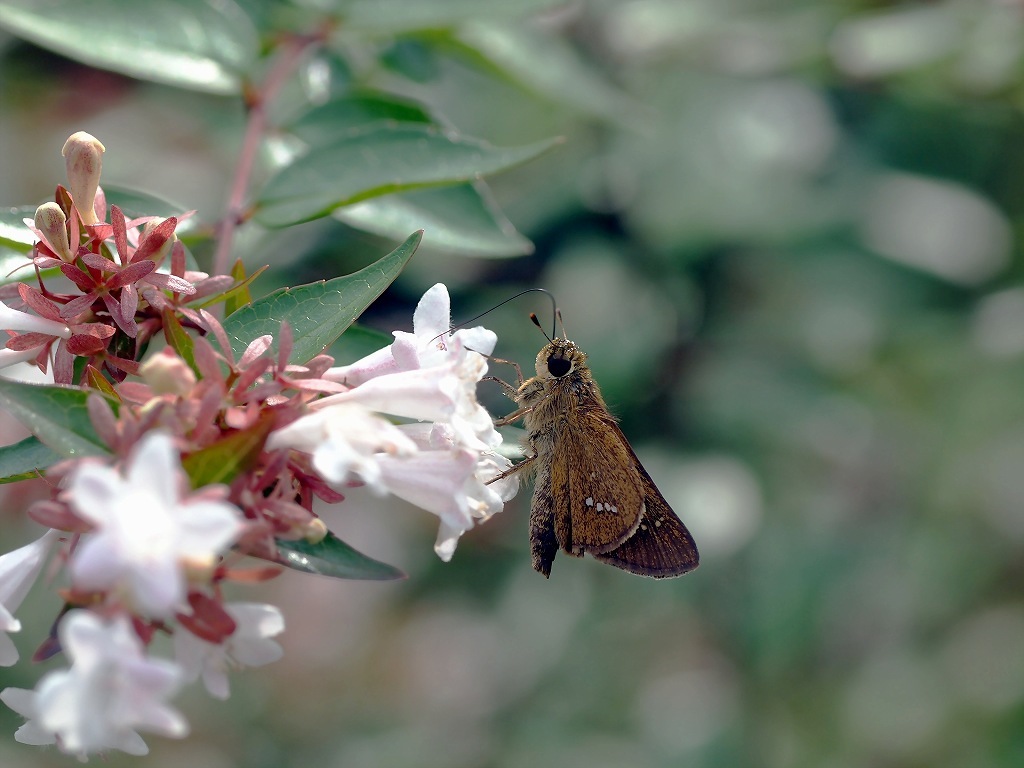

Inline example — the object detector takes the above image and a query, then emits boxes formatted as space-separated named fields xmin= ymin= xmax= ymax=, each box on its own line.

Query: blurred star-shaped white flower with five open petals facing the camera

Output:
xmin=67 ymin=432 xmax=245 ymax=617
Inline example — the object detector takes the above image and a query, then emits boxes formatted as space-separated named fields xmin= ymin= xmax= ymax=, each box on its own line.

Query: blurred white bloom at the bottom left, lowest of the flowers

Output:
xmin=0 ymin=610 xmax=188 ymax=756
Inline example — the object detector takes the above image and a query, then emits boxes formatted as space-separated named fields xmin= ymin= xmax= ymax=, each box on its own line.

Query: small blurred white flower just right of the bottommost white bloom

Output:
xmin=174 ymin=603 xmax=285 ymax=698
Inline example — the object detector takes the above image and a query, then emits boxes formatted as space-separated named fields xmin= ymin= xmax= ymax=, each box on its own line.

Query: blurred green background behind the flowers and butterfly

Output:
xmin=0 ymin=0 xmax=1024 ymax=768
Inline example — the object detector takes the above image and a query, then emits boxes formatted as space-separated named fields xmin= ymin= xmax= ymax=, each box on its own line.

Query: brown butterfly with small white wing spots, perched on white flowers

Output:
xmin=496 ymin=315 xmax=699 ymax=579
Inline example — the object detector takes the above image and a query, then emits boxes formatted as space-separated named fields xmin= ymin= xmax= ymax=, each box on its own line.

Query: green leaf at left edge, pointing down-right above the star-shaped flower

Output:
xmin=0 ymin=379 xmax=116 ymax=458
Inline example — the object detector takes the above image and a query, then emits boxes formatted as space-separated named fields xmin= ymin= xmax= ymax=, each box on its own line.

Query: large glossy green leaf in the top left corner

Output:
xmin=0 ymin=0 xmax=259 ymax=95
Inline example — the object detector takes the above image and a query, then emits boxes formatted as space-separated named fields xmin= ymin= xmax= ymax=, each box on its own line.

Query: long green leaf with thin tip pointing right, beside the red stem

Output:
xmin=255 ymin=125 xmax=559 ymax=226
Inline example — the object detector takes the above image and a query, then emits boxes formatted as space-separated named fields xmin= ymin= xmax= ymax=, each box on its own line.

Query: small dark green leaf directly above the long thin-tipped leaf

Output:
xmin=289 ymin=91 xmax=433 ymax=145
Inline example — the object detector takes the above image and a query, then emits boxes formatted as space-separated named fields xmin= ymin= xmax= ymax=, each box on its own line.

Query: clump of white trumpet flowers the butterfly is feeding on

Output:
xmin=267 ymin=284 xmax=518 ymax=560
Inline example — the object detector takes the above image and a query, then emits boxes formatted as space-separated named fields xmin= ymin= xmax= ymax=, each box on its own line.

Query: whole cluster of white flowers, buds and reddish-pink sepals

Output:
xmin=0 ymin=133 xmax=517 ymax=757
